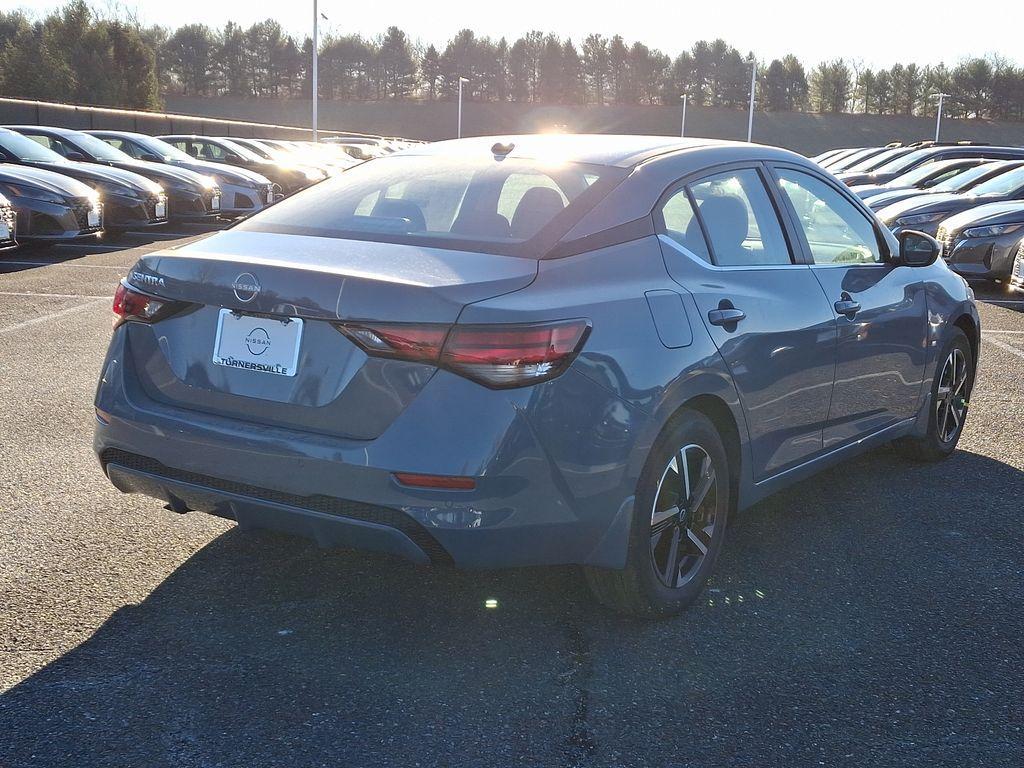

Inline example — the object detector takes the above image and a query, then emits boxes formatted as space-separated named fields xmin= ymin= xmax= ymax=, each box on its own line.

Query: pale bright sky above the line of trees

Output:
xmin=0 ymin=0 xmax=1024 ymax=68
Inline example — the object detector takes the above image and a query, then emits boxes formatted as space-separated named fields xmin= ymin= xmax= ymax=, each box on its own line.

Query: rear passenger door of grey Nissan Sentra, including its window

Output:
xmin=655 ymin=165 xmax=836 ymax=480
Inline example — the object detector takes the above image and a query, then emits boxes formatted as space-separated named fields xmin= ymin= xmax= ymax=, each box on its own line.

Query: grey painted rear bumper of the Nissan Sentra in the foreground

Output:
xmin=94 ymin=328 xmax=644 ymax=568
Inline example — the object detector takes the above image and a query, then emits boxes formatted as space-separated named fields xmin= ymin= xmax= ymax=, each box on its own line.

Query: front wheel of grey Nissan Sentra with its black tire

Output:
xmin=895 ymin=328 xmax=975 ymax=462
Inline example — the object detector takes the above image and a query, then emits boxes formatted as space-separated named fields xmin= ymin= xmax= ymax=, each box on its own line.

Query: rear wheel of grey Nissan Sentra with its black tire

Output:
xmin=584 ymin=410 xmax=731 ymax=617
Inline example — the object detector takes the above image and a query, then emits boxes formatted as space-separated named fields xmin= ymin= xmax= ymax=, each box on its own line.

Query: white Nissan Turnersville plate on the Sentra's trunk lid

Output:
xmin=213 ymin=309 xmax=302 ymax=376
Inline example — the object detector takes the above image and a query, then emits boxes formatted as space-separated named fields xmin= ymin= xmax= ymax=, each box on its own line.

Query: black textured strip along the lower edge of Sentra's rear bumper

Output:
xmin=99 ymin=449 xmax=453 ymax=565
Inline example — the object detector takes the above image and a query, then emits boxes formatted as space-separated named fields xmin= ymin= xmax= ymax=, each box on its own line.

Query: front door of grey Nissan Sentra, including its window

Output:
xmin=773 ymin=165 xmax=928 ymax=450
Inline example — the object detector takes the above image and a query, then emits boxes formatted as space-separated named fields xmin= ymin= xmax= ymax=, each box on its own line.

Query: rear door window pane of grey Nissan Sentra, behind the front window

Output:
xmin=689 ymin=169 xmax=793 ymax=266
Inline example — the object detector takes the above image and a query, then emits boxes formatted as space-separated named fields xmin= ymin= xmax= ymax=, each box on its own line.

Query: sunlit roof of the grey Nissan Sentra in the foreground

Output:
xmin=400 ymin=133 xmax=750 ymax=168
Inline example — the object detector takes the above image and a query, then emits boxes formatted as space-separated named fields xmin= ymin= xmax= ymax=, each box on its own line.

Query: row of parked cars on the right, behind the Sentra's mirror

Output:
xmin=814 ymin=141 xmax=1024 ymax=288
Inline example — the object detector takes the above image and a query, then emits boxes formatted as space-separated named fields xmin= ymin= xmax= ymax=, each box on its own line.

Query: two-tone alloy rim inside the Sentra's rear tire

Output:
xmin=650 ymin=444 xmax=718 ymax=589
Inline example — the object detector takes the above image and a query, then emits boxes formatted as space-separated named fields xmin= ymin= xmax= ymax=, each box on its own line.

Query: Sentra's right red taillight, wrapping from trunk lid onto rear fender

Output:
xmin=341 ymin=319 xmax=590 ymax=388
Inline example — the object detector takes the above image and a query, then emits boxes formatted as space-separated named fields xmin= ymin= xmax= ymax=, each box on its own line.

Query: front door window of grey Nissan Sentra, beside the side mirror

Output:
xmin=778 ymin=169 xmax=882 ymax=264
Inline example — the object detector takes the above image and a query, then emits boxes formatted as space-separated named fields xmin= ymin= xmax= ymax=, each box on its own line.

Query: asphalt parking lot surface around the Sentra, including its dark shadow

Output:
xmin=0 ymin=226 xmax=1024 ymax=768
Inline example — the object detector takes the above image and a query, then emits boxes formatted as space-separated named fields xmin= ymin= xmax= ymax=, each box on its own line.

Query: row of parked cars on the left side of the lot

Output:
xmin=0 ymin=125 xmax=415 ymax=250
